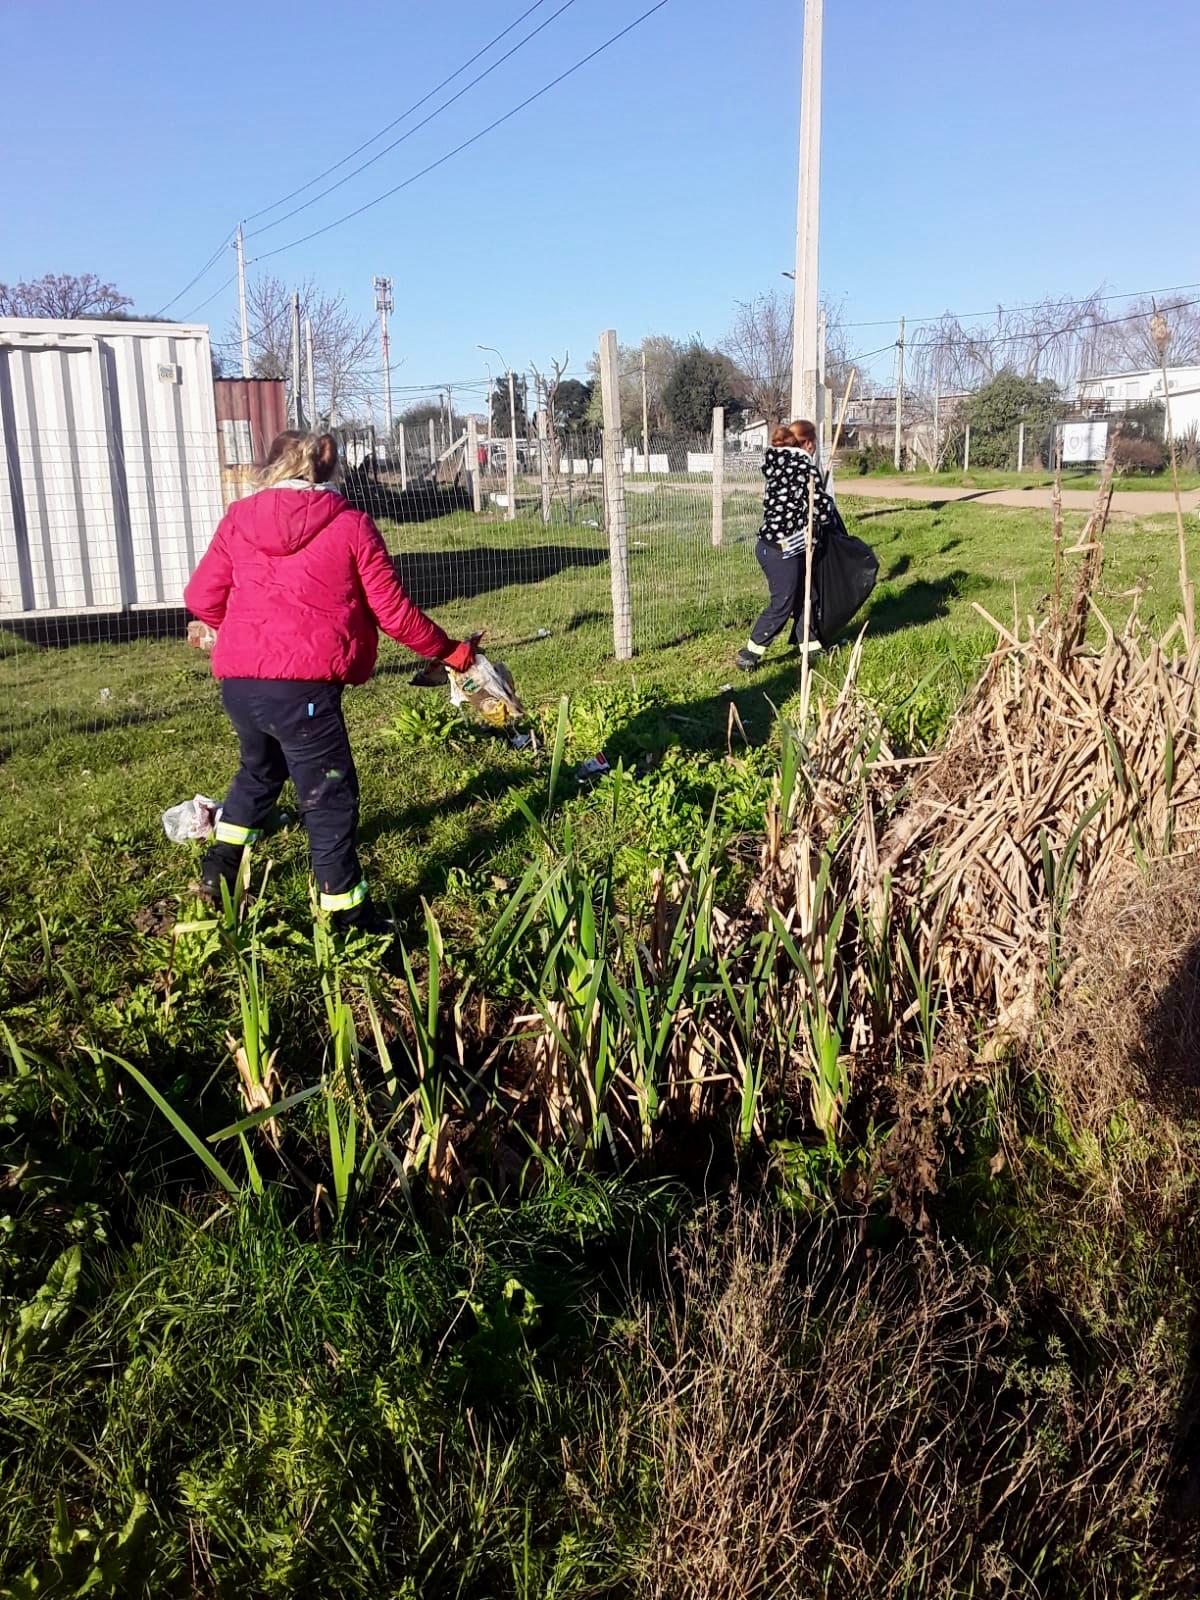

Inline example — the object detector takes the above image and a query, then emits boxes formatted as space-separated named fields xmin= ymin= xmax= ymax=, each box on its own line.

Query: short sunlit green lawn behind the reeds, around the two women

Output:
xmin=0 ymin=494 xmax=1174 ymax=954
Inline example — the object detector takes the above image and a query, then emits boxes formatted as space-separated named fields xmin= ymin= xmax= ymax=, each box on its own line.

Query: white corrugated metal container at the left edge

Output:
xmin=0 ymin=317 xmax=222 ymax=618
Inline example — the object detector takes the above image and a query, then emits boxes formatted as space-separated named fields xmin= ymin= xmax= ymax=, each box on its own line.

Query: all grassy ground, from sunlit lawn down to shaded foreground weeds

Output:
xmin=0 ymin=490 xmax=1200 ymax=1600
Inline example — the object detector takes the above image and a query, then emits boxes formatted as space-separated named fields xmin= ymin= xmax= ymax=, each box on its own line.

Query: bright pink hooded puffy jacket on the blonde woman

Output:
xmin=184 ymin=488 xmax=454 ymax=683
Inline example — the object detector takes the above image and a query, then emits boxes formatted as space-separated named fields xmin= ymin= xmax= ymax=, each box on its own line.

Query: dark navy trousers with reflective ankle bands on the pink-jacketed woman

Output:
xmin=205 ymin=678 xmax=366 ymax=910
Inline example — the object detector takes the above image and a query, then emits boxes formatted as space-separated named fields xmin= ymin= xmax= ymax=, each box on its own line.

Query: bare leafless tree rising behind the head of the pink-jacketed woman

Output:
xmin=221 ymin=275 xmax=378 ymax=422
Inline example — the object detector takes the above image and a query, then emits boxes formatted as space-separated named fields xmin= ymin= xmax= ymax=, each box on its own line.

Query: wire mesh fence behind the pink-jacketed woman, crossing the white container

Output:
xmin=0 ymin=400 xmax=762 ymax=765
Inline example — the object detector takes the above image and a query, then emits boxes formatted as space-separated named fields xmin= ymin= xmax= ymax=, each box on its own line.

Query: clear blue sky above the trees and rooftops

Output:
xmin=0 ymin=0 xmax=1200 ymax=398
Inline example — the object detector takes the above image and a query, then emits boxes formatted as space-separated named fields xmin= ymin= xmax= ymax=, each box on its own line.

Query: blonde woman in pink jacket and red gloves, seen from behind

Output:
xmin=184 ymin=432 xmax=474 ymax=931
